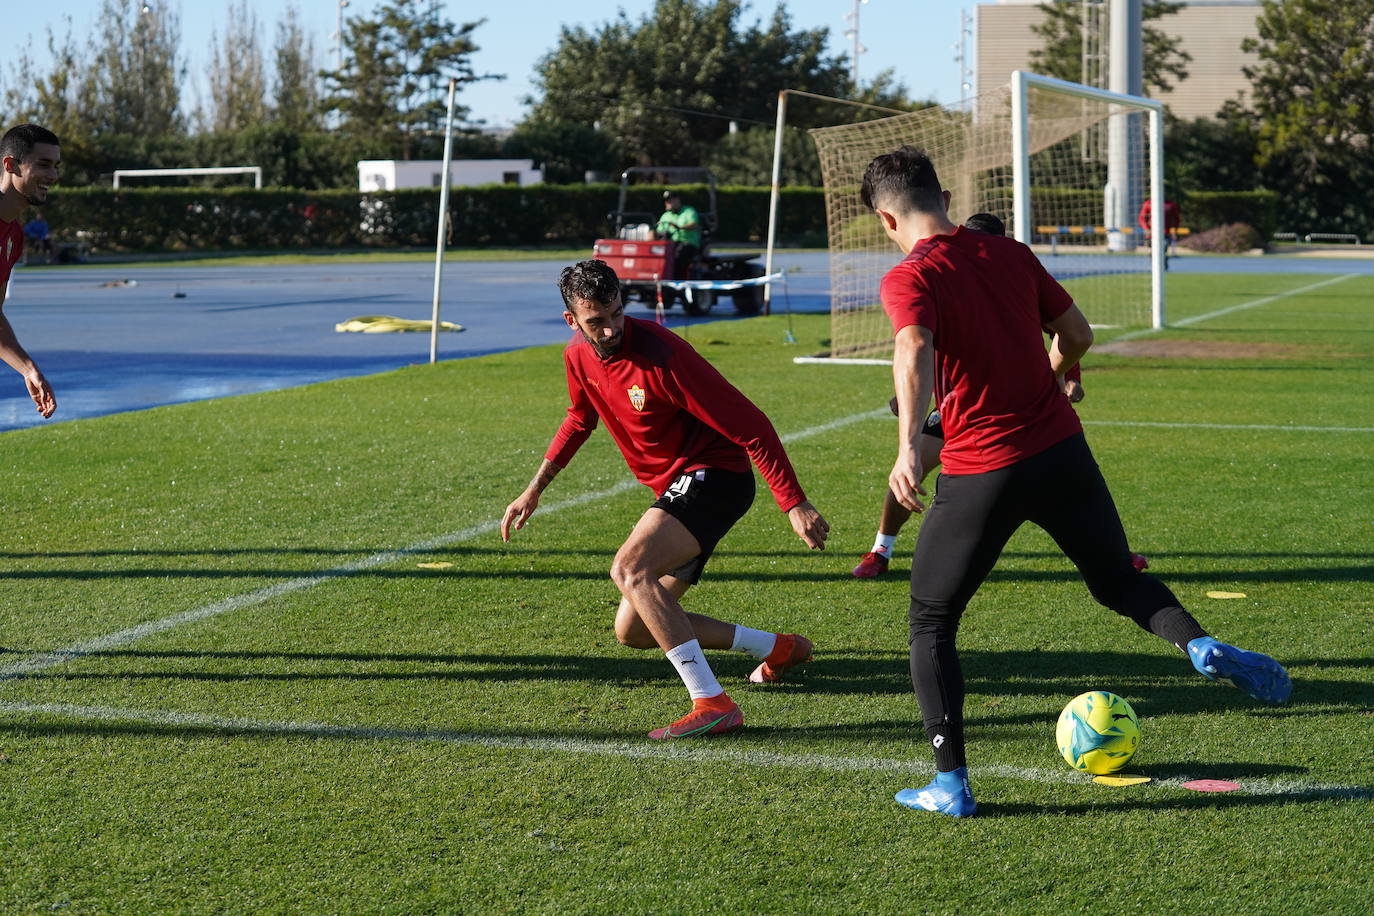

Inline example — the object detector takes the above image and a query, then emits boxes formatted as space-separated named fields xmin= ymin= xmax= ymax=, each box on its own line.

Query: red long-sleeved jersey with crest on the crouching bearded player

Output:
xmin=544 ymin=317 xmax=807 ymax=512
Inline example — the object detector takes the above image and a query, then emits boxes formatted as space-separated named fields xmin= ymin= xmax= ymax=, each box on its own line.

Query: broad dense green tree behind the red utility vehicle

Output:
xmin=530 ymin=0 xmax=908 ymax=165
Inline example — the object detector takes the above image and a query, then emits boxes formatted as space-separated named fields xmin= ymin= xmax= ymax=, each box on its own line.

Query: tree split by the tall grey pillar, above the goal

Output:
xmin=1031 ymin=0 xmax=1193 ymax=96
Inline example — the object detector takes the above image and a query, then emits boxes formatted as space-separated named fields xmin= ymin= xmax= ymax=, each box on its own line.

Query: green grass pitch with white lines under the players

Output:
xmin=0 ymin=275 xmax=1374 ymax=916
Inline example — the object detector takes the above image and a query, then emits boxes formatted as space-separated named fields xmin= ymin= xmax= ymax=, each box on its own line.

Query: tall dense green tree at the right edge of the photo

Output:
xmin=1242 ymin=0 xmax=1374 ymax=235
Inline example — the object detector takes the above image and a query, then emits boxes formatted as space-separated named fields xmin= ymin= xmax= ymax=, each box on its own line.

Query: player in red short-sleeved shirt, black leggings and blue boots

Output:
xmin=861 ymin=147 xmax=1292 ymax=817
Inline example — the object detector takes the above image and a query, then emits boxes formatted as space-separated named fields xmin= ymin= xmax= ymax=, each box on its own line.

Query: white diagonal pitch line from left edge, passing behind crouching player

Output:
xmin=0 ymin=409 xmax=888 ymax=687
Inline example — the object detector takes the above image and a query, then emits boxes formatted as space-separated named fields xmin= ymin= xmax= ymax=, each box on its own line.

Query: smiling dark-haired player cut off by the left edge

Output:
xmin=0 ymin=124 xmax=62 ymax=419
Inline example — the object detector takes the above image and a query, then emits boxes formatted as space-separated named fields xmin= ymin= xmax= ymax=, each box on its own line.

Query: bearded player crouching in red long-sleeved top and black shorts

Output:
xmin=502 ymin=261 xmax=830 ymax=739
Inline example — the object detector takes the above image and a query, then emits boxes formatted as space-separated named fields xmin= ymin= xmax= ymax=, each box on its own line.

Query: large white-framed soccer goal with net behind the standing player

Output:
xmin=807 ymin=70 xmax=1167 ymax=361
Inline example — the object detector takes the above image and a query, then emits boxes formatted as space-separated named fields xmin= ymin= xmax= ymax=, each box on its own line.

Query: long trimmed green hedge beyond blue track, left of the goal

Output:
xmin=44 ymin=184 xmax=826 ymax=251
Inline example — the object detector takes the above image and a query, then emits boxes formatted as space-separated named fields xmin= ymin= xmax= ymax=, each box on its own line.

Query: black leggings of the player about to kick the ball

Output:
xmin=910 ymin=433 xmax=1206 ymax=770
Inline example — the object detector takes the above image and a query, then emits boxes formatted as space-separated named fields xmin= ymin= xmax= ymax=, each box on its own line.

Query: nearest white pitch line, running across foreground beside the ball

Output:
xmin=0 ymin=700 xmax=1374 ymax=799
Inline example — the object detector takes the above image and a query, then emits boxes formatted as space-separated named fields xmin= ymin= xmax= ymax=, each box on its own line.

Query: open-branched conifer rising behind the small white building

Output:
xmin=323 ymin=0 xmax=497 ymax=159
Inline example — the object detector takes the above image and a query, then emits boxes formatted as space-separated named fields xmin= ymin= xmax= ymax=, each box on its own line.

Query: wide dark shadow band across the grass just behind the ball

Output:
xmin=8 ymin=644 xmax=1374 ymax=732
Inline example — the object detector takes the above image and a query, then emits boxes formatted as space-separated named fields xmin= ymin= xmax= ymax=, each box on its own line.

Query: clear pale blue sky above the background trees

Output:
xmin=0 ymin=0 xmax=976 ymax=126
